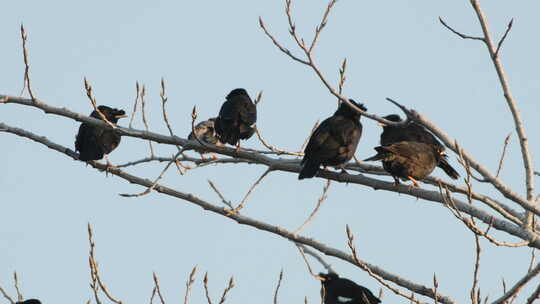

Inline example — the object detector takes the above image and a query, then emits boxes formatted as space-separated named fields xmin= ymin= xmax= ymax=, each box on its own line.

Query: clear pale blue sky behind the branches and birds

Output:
xmin=0 ymin=0 xmax=540 ymax=304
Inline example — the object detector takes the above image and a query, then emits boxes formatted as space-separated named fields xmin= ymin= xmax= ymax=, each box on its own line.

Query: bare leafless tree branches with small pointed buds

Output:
xmin=0 ymin=0 xmax=540 ymax=304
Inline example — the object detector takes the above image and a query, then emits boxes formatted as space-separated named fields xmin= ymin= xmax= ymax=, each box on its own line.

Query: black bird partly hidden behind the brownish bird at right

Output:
xmin=380 ymin=114 xmax=459 ymax=179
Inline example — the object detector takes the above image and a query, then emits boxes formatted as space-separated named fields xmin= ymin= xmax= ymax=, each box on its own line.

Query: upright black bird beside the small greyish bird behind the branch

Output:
xmin=215 ymin=89 xmax=257 ymax=147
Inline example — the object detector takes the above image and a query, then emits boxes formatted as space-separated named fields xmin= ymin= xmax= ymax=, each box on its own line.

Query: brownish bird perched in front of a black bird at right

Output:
xmin=364 ymin=141 xmax=441 ymax=187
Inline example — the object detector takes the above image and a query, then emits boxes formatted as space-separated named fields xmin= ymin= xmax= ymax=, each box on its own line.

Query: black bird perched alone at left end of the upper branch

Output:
xmin=75 ymin=106 xmax=126 ymax=161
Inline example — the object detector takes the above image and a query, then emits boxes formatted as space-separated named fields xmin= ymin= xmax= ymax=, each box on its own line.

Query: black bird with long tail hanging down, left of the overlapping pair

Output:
xmin=298 ymin=99 xmax=367 ymax=179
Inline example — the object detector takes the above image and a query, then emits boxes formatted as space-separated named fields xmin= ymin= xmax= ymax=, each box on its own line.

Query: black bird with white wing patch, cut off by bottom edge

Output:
xmin=319 ymin=272 xmax=381 ymax=304
